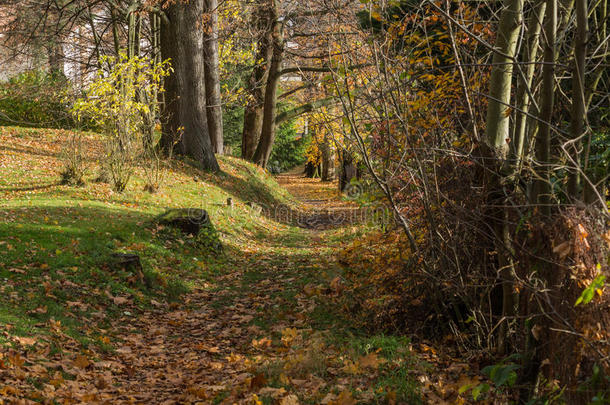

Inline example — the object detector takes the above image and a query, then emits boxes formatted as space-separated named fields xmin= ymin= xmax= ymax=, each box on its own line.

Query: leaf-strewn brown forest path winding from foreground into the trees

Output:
xmin=91 ymin=171 xmax=379 ymax=404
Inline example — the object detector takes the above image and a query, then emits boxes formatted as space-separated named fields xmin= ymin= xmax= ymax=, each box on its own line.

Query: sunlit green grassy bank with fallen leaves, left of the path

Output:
xmin=0 ymin=127 xmax=294 ymax=346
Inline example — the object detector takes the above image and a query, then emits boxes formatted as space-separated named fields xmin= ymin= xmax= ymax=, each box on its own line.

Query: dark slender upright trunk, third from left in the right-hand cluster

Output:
xmin=532 ymin=0 xmax=557 ymax=217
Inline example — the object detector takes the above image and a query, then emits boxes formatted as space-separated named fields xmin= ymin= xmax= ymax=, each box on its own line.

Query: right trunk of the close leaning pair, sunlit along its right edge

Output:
xmin=252 ymin=0 xmax=284 ymax=168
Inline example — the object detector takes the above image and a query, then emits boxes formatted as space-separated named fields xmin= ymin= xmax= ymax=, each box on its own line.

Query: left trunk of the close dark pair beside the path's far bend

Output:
xmin=241 ymin=1 xmax=273 ymax=160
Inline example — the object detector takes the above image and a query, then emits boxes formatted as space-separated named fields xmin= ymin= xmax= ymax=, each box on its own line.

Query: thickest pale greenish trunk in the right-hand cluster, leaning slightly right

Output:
xmin=486 ymin=0 xmax=523 ymax=158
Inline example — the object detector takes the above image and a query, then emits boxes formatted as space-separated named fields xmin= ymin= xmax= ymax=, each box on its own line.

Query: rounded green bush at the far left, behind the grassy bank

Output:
xmin=0 ymin=70 xmax=76 ymax=129
